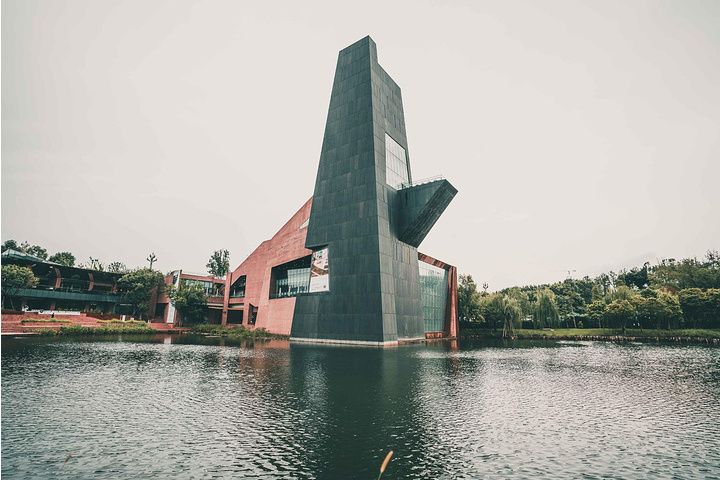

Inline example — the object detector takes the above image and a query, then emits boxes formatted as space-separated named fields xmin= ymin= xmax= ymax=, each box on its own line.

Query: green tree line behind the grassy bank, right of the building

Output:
xmin=458 ymin=251 xmax=720 ymax=330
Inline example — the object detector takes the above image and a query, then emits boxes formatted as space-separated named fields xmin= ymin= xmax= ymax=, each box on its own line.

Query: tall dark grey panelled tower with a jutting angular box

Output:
xmin=291 ymin=37 xmax=457 ymax=344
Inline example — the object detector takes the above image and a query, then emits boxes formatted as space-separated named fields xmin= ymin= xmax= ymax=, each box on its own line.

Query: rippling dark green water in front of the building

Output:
xmin=2 ymin=336 xmax=720 ymax=479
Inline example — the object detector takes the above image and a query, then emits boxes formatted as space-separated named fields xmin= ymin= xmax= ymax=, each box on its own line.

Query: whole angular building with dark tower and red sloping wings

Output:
xmin=156 ymin=37 xmax=457 ymax=345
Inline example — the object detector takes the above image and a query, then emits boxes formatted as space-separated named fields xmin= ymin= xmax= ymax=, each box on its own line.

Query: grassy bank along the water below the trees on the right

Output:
xmin=460 ymin=328 xmax=720 ymax=344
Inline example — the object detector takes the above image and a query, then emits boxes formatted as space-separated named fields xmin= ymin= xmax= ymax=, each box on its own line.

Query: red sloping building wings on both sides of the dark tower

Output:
xmin=156 ymin=198 xmax=457 ymax=338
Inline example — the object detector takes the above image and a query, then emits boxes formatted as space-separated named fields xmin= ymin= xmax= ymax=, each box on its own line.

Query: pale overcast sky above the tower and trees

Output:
xmin=2 ymin=0 xmax=720 ymax=290
